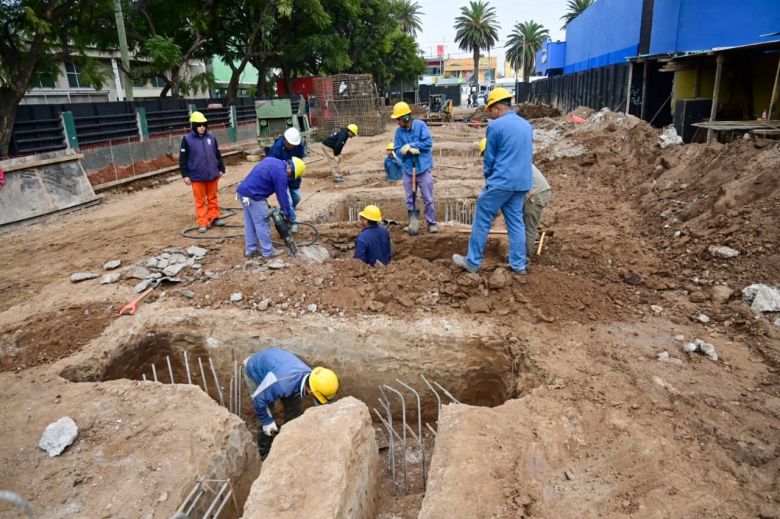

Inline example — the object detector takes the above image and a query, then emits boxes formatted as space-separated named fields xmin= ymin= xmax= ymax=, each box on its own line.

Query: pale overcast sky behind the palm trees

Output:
xmin=416 ymin=0 xmax=567 ymax=63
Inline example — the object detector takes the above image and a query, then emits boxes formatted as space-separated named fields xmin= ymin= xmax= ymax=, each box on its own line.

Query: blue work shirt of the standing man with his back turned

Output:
xmin=482 ymin=111 xmax=534 ymax=191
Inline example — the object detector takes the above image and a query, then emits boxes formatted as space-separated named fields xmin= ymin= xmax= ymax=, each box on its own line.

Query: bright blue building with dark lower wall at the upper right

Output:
xmin=529 ymin=0 xmax=780 ymax=138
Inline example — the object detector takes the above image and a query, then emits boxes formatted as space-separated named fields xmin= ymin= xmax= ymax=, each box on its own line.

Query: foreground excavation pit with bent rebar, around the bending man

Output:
xmin=62 ymin=313 xmax=517 ymax=517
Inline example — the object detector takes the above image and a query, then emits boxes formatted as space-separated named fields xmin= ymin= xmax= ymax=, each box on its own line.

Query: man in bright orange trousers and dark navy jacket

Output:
xmin=179 ymin=112 xmax=225 ymax=232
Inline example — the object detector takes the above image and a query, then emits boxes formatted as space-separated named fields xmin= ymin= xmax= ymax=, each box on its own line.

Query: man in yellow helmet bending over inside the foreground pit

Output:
xmin=244 ymin=348 xmax=339 ymax=460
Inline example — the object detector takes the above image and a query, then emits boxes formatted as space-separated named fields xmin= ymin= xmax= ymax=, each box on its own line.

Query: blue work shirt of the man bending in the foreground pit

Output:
xmin=246 ymin=348 xmax=311 ymax=425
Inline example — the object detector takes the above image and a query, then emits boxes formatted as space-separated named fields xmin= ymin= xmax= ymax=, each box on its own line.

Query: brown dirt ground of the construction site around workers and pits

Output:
xmin=0 ymin=103 xmax=780 ymax=519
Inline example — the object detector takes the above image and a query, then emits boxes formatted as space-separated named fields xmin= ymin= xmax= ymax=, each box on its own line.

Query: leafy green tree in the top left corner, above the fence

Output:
xmin=0 ymin=0 xmax=114 ymax=156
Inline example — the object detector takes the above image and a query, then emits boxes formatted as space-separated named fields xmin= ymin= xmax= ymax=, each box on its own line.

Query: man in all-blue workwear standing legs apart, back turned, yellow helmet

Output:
xmin=452 ymin=87 xmax=533 ymax=275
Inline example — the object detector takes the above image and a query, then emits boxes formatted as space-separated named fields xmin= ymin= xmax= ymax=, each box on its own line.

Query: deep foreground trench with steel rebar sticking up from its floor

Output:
xmin=63 ymin=329 xmax=514 ymax=514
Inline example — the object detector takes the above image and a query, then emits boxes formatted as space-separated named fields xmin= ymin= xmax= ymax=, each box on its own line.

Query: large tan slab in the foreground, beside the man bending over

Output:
xmin=243 ymin=397 xmax=380 ymax=519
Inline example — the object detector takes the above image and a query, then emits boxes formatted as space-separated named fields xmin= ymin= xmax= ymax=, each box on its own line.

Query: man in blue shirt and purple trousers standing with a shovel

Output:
xmin=390 ymin=101 xmax=438 ymax=235
